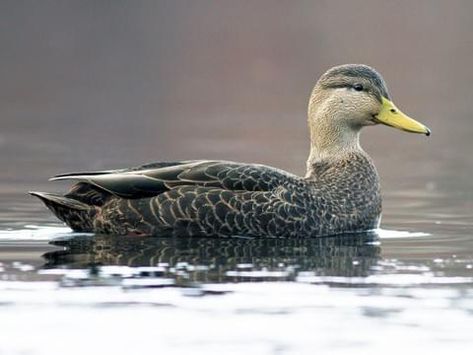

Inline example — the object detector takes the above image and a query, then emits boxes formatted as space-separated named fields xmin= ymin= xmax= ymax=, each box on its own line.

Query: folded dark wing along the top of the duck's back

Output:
xmin=51 ymin=160 xmax=300 ymax=199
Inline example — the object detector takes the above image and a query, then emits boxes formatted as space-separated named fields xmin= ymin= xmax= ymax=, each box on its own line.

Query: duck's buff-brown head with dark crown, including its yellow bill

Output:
xmin=309 ymin=64 xmax=430 ymax=161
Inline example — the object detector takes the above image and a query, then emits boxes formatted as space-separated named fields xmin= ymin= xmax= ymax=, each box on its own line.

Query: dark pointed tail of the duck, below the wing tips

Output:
xmin=30 ymin=191 xmax=96 ymax=232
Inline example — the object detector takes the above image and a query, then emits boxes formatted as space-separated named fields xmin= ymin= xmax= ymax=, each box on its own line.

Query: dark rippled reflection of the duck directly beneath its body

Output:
xmin=44 ymin=232 xmax=380 ymax=282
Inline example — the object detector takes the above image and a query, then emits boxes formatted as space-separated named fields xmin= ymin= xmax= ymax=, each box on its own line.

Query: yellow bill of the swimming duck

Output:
xmin=375 ymin=97 xmax=430 ymax=136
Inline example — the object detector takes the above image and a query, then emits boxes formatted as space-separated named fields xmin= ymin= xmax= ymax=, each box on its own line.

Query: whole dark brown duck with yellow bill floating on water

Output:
xmin=30 ymin=64 xmax=431 ymax=238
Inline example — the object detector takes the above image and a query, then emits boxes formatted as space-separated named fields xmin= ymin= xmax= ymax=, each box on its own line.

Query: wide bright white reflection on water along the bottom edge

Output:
xmin=0 ymin=282 xmax=473 ymax=355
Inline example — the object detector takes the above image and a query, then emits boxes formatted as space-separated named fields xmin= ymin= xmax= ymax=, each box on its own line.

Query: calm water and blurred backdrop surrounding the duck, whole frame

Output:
xmin=0 ymin=0 xmax=473 ymax=355
